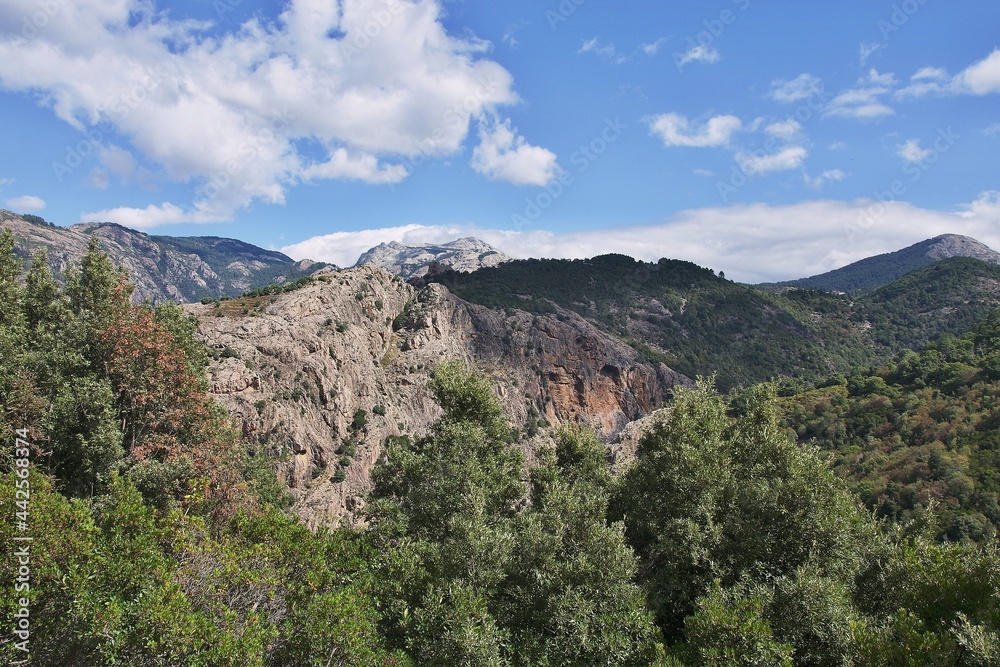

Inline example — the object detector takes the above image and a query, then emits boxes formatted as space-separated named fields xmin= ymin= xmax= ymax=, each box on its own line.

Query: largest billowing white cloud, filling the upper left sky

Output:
xmin=0 ymin=0 xmax=548 ymax=227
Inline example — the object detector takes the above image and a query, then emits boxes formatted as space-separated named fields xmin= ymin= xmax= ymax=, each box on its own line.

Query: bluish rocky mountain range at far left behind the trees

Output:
xmin=0 ymin=210 xmax=324 ymax=303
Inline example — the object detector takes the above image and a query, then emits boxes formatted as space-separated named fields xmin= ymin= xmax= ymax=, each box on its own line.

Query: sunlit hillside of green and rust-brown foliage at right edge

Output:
xmin=785 ymin=313 xmax=1000 ymax=541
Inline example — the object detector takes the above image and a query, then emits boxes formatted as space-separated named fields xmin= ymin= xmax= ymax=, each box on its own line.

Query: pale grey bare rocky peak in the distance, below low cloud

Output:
xmin=355 ymin=237 xmax=510 ymax=280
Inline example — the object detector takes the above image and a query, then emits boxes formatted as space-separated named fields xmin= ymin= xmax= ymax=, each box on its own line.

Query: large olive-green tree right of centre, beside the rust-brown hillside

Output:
xmin=615 ymin=381 xmax=873 ymax=640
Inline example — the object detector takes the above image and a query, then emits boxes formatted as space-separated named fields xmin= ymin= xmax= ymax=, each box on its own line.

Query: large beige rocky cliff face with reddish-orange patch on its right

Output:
xmin=188 ymin=266 xmax=688 ymax=526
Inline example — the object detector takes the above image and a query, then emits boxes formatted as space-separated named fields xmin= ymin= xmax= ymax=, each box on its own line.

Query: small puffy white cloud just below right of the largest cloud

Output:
xmin=471 ymin=118 xmax=559 ymax=186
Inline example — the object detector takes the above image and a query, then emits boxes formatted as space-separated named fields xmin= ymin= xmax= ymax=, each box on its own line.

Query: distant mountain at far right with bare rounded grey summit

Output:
xmin=778 ymin=234 xmax=1000 ymax=292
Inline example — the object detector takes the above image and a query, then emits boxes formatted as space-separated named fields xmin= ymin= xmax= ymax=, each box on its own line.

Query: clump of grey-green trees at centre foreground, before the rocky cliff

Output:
xmin=369 ymin=365 xmax=655 ymax=666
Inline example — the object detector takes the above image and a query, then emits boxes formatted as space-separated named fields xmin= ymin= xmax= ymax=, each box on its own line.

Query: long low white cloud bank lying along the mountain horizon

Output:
xmin=282 ymin=193 xmax=1000 ymax=282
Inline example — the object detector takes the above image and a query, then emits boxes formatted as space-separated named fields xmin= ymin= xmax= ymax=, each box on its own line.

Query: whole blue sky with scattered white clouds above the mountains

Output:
xmin=0 ymin=0 xmax=1000 ymax=282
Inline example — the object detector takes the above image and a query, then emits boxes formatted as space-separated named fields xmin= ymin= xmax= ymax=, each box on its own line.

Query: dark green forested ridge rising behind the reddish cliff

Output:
xmin=431 ymin=255 xmax=1000 ymax=391
